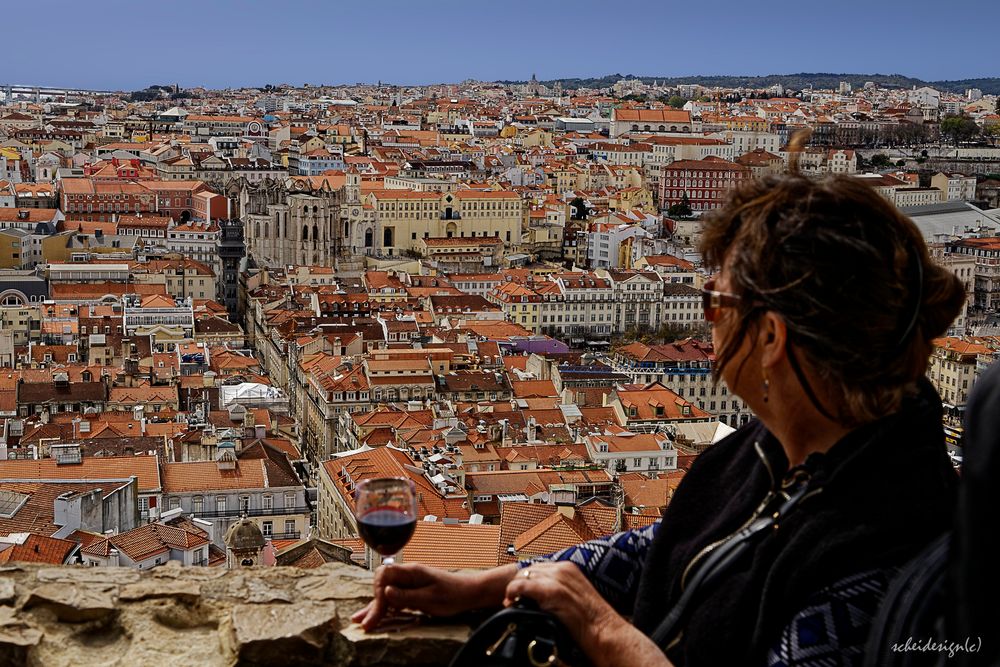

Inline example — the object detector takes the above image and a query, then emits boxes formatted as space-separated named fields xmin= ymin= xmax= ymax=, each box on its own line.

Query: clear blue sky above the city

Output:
xmin=0 ymin=0 xmax=1000 ymax=90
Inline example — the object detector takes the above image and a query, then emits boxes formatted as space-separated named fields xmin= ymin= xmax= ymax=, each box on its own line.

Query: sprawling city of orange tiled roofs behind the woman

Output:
xmin=0 ymin=2 xmax=1000 ymax=662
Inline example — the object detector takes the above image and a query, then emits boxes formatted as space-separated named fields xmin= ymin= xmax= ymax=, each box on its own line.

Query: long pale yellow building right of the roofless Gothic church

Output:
xmin=365 ymin=190 xmax=523 ymax=255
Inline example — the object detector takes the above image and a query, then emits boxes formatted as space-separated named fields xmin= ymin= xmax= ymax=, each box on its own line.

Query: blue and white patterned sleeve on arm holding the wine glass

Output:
xmin=517 ymin=521 xmax=660 ymax=614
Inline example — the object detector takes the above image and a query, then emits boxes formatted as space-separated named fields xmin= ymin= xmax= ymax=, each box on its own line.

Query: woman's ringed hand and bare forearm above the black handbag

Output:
xmin=503 ymin=561 xmax=670 ymax=667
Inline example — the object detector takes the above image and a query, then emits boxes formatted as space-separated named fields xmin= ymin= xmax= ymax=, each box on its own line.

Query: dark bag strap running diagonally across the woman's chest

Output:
xmin=649 ymin=483 xmax=812 ymax=650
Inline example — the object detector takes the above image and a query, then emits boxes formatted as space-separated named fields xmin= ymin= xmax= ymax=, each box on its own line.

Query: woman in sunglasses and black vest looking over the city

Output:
xmin=355 ymin=176 xmax=965 ymax=666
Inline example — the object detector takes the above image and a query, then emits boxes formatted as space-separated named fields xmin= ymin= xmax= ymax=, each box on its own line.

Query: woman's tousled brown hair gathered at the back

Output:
xmin=701 ymin=175 xmax=966 ymax=425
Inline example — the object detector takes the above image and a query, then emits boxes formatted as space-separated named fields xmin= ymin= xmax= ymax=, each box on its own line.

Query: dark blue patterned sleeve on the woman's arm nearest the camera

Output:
xmin=766 ymin=569 xmax=894 ymax=667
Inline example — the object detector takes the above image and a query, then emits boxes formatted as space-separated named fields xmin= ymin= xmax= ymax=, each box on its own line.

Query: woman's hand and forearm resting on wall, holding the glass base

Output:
xmin=351 ymin=563 xmax=516 ymax=632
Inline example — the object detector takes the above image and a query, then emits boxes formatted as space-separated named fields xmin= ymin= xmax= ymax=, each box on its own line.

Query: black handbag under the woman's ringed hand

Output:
xmin=450 ymin=598 xmax=590 ymax=667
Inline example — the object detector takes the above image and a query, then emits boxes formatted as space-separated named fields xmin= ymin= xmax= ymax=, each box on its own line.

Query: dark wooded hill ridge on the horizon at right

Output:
xmin=497 ymin=72 xmax=1000 ymax=95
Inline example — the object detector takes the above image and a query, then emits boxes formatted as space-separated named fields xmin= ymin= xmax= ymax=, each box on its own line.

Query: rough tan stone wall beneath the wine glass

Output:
xmin=0 ymin=563 xmax=468 ymax=667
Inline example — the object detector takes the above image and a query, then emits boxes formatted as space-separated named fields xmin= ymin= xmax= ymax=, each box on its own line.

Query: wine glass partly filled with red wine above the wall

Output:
xmin=354 ymin=477 xmax=417 ymax=565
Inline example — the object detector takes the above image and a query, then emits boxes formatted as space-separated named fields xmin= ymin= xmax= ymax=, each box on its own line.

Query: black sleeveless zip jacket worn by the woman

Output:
xmin=633 ymin=381 xmax=958 ymax=667
